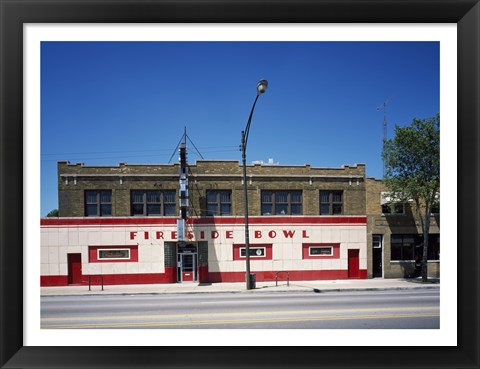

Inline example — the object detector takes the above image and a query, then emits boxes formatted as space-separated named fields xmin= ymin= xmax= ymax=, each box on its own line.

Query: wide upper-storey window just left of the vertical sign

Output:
xmin=131 ymin=190 xmax=176 ymax=216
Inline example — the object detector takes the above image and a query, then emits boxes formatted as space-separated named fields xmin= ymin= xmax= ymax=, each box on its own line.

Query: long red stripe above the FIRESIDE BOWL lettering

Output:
xmin=40 ymin=215 xmax=367 ymax=227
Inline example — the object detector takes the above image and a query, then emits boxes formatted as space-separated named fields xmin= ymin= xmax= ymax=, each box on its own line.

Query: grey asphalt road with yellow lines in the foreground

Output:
xmin=41 ymin=289 xmax=440 ymax=329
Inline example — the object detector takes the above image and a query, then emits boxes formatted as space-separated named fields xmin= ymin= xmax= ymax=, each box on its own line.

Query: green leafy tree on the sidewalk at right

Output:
xmin=382 ymin=114 xmax=440 ymax=282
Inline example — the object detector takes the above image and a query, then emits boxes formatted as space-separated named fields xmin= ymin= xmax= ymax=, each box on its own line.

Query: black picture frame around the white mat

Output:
xmin=0 ymin=0 xmax=480 ymax=369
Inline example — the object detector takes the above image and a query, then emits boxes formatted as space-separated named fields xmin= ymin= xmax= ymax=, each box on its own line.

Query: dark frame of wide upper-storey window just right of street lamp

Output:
xmin=260 ymin=190 xmax=303 ymax=216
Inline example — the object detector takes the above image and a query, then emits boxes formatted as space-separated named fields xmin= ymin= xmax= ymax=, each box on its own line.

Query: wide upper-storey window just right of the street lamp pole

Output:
xmin=261 ymin=191 xmax=303 ymax=215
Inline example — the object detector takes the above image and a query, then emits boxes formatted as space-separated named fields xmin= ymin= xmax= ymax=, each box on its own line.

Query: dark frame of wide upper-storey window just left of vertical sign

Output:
xmin=130 ymin=190 xmax=177 ymax=216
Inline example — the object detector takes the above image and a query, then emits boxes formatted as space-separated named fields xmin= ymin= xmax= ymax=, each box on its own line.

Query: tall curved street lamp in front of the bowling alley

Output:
xmin=242 ymin=79 xmax=268 ymax=290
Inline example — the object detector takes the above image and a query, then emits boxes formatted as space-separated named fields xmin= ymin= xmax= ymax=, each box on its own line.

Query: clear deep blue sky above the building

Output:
xmin=40 ymin=42 xmax=440 ymax=216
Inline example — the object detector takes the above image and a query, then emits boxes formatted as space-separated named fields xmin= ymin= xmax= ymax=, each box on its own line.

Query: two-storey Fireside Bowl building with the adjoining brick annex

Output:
xmin=41 ymin=160 xmax=438 ymax=286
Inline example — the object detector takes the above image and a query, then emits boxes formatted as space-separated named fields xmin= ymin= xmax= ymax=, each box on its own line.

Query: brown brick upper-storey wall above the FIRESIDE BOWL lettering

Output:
xmin=58 ymin=161 xmax=366 ymax=217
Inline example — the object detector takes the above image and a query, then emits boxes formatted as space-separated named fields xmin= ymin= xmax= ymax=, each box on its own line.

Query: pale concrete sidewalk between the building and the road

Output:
xmin=40 ymin=279 xmax=440 ymax=296
